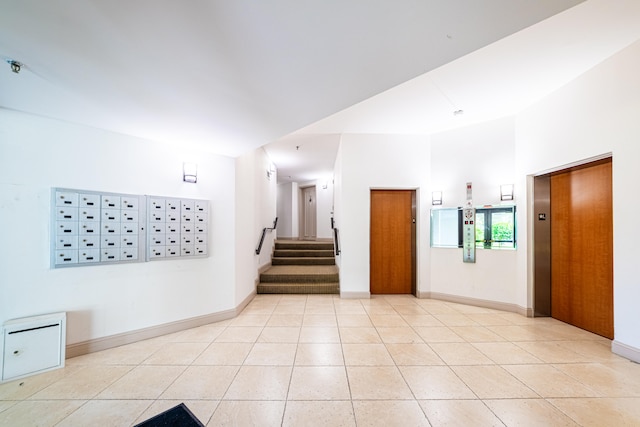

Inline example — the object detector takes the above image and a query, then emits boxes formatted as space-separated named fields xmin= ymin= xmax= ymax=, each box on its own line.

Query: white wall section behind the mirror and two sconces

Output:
xmin=425 ymin=118 xmax=526 ymax=308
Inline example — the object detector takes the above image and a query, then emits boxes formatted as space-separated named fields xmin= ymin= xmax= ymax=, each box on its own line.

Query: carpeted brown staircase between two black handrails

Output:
xmin=258 ymin=240 xmax=340 ymax=294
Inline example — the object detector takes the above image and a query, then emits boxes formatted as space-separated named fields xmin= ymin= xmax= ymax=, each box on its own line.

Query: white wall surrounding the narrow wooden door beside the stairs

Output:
xmin=335 ymin=135 xmax=431 ymax=296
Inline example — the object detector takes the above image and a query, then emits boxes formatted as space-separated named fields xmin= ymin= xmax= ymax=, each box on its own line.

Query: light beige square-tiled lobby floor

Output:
xmin=0 ymin=295 xmax=640 ymax=427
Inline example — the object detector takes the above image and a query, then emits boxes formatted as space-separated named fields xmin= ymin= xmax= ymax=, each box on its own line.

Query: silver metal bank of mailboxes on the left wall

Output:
xmin=51 ymin=188 xmax=209 ymax=268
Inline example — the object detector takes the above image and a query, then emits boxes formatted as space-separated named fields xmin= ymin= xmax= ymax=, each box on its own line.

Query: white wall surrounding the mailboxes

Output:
xmin=0 ymin=109 xmax=236 ymax=344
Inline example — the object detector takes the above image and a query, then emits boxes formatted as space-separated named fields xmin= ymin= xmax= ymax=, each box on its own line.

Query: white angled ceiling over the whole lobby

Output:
xmin=0 ymin=0 xmax=640 ymax=185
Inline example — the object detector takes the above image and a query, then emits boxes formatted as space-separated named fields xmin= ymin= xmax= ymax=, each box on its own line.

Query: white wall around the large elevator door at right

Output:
xmin=516 ymin=38 xmax=640 ymax=359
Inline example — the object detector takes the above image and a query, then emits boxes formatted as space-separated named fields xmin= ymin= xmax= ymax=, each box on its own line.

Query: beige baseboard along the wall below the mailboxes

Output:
xmin=65 ymin=292 xmax=256 ymax=359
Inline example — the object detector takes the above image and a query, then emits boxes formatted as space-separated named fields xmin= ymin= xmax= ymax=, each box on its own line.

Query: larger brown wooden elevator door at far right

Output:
xmin=551 ymin=159 xmax=613 ymax=339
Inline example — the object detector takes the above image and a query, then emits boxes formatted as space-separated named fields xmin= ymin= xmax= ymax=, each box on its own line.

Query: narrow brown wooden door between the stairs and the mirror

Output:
xmin=369 ymin=190 xmax=415 ymax=294
